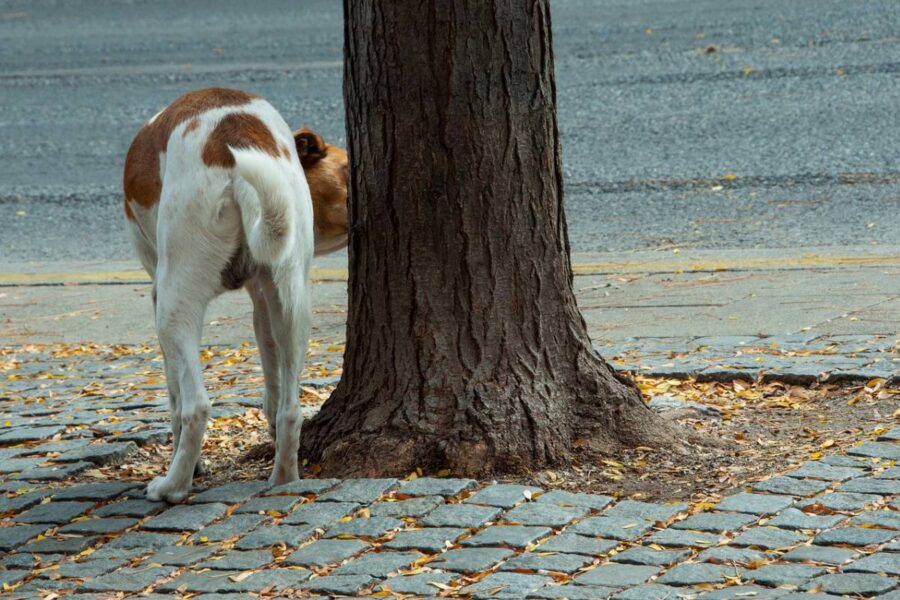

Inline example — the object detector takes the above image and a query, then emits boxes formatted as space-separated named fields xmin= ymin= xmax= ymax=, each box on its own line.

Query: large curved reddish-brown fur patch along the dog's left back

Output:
xmin=123 ymin=88 xmax=256 ymax=219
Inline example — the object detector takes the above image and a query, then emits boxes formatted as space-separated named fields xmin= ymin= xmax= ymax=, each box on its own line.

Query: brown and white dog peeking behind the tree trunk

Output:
xmin=124 ymin=88 xmax=349 ymax=502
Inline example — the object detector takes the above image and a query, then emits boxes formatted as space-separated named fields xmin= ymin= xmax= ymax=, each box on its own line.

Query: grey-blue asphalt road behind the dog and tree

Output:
xmin=0 ymin=0 xmax=900 ymax=261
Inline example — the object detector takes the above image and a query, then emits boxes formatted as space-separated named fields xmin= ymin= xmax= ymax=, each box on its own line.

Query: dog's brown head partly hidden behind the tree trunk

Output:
xmin=294 ymin=128 xmax=350 ymax=256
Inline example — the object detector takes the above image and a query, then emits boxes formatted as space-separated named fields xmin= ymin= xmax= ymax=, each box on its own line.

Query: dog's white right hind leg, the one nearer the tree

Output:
xmin=254 ymin=261 xmax=311 ymax=485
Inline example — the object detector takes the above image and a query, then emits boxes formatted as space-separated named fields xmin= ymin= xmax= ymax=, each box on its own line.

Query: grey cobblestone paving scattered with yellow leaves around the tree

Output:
xmin=0 ymin=350 xmax=900 ymax=600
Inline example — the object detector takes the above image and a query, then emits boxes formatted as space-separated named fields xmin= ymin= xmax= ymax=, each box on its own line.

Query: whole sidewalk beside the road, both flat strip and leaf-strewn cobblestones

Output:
xmin=0 ymin=248 xmax=900 ymax=600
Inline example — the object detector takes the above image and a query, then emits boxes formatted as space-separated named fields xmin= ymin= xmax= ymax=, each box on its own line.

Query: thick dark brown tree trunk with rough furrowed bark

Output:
xmin=301 ymin=0 xmax=671 ymax=476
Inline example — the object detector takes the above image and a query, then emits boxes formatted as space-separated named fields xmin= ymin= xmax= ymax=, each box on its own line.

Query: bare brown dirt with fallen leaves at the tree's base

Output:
xmin=197 ymin=377 xmax=900 ymax=501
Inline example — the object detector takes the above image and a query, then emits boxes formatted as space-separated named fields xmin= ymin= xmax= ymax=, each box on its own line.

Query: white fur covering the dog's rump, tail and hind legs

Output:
xmin=129 ymin=100 xmax=314 ymax=502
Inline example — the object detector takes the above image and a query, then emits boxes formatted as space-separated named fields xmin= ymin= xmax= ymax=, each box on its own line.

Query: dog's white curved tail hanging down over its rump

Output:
xmin=229 ymin=147 xmax=297 ymax=265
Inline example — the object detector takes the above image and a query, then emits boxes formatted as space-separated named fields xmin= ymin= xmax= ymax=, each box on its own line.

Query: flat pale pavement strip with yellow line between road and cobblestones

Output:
xmin=0 ymin=247 xmax=900 ymax=382
